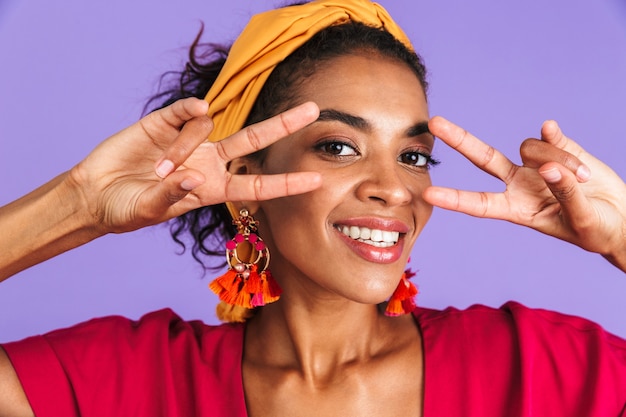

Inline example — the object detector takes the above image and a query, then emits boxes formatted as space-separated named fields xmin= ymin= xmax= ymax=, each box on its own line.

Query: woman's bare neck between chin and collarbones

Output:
xmin=245 ymin=297 xmax=417 ymax=385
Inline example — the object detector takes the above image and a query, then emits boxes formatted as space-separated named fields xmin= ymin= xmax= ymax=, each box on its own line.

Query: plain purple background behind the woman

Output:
xmin=0 ymin=0 xmax=626 ymax=341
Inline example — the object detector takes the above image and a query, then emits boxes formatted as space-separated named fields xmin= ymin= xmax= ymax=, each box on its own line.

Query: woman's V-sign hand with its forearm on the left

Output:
xmin=0 ymin=98 xmax=321 ymax=281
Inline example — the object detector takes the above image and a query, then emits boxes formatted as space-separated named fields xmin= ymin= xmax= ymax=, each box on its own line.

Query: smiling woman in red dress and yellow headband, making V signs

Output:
xmin=0 ymin=1 xmax=626 ymax=415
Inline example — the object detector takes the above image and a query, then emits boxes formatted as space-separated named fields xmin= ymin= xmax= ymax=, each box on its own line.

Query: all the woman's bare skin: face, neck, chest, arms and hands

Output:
xmin=0 ymin=50 xmax=626 ymax=417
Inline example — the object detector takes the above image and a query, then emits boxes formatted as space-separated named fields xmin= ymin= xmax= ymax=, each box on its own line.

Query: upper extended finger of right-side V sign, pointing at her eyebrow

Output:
xmin=428 ymin=116 xmax=517 ymax=184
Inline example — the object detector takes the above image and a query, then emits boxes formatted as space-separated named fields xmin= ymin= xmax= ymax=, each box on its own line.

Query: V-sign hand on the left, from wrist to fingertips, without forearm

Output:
xmin=67 ymin=98 xmax=321 ymax=233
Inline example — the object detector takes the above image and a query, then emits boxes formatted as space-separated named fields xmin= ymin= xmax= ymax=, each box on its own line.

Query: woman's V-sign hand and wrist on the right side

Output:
xmin=424 ymin=117 xmax=626 ymax=272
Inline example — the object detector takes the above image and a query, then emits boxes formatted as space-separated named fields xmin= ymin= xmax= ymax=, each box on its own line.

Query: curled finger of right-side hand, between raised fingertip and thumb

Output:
xmin=520 ymin=139 xmax=591 ymax=182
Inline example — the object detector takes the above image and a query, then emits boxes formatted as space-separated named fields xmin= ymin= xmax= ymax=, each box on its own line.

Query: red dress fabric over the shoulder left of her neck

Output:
xmin=3 ymin=309 xmax=244 ymax=415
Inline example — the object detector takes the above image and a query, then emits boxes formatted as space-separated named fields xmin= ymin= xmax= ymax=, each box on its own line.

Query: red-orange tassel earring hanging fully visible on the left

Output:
xmin=209 ymin=209 xmax=282 ymax=309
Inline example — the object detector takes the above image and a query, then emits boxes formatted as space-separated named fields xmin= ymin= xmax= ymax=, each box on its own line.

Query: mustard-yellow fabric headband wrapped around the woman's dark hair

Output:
xmin=205 ymin=0 xmax=413 ymax=216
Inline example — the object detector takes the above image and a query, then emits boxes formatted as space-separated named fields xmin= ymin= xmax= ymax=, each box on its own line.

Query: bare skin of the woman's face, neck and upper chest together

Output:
xmin=233 ymin=55 xmax=434 ymax=416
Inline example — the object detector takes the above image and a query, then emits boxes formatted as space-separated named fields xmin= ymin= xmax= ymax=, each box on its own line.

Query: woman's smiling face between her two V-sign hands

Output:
xmin=249 ymin=54 xmax=434 ymax=303
